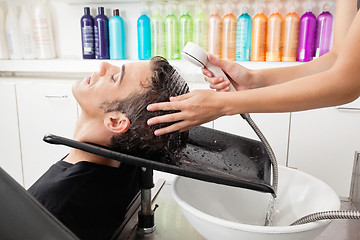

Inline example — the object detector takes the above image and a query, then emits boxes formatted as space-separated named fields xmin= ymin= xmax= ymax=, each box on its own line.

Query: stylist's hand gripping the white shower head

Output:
xmin=202 ymin=54 xmax=252 ymax=92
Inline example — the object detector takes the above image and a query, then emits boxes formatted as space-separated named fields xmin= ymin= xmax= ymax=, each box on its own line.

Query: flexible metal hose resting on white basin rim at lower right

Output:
xmin=290 ymin=211 xmax=360 ymax=226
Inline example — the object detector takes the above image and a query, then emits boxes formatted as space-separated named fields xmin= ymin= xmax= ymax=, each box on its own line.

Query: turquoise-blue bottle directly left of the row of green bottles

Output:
xmin=137 ymin=12 xmax=151 ymax=60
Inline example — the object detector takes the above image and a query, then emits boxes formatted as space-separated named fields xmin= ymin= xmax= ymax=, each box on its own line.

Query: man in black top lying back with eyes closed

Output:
xmin=28 ymin=57 xmax=189 ymax=240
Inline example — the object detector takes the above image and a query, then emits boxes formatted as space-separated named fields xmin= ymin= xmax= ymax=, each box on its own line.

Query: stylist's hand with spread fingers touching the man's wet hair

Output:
xmin=147 ymin=90 xmax=224 ymax=136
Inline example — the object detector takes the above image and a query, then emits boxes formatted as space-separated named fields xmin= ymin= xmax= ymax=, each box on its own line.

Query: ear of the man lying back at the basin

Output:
xmin=104 ymin=112 xmax=130 ymax=134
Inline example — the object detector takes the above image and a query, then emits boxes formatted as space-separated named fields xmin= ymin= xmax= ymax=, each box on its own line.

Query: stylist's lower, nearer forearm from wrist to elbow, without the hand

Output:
xmin=223 ymin=66 xmax=360 ymax=115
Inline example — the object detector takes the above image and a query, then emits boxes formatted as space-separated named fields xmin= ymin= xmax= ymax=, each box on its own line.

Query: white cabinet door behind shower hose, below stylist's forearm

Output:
xmin=214 ymin=113 xmax=290 ymax=166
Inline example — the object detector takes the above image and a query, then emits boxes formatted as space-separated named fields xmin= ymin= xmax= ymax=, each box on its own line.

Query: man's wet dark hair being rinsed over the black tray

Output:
xmin=104 ymin=57 xmax=189 ymax=164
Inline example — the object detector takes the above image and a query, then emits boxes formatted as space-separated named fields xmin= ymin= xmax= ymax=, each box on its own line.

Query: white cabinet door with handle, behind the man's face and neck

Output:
xmin=16 ymin=80 xmax=77 ymax=188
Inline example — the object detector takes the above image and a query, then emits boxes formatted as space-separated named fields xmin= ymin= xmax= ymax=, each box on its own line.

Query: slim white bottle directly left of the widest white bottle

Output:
xmin=19 ymin=5 xmax=36 ymax=59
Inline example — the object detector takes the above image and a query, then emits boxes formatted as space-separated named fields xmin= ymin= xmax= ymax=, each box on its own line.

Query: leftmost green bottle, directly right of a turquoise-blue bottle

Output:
xmin=151 ymin=9 xmax=166 ymax=57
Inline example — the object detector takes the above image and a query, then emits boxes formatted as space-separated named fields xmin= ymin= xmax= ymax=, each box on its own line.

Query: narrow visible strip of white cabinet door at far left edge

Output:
xmin=0 ymin=83 xmax=23 ymax=185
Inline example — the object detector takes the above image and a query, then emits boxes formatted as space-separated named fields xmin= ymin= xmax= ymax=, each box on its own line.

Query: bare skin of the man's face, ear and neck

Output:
xmin=64 ymin=62 xmax=151 ymax=167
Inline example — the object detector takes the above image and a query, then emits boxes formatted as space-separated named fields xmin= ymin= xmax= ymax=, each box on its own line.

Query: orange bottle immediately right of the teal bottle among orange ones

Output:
xmin=250 ymin=9 xmax=267 ymax=61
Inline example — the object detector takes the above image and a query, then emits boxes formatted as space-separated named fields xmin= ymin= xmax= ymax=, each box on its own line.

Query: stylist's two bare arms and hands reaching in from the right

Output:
xmin=148 ymin=0 xmax=360 ymax=135
